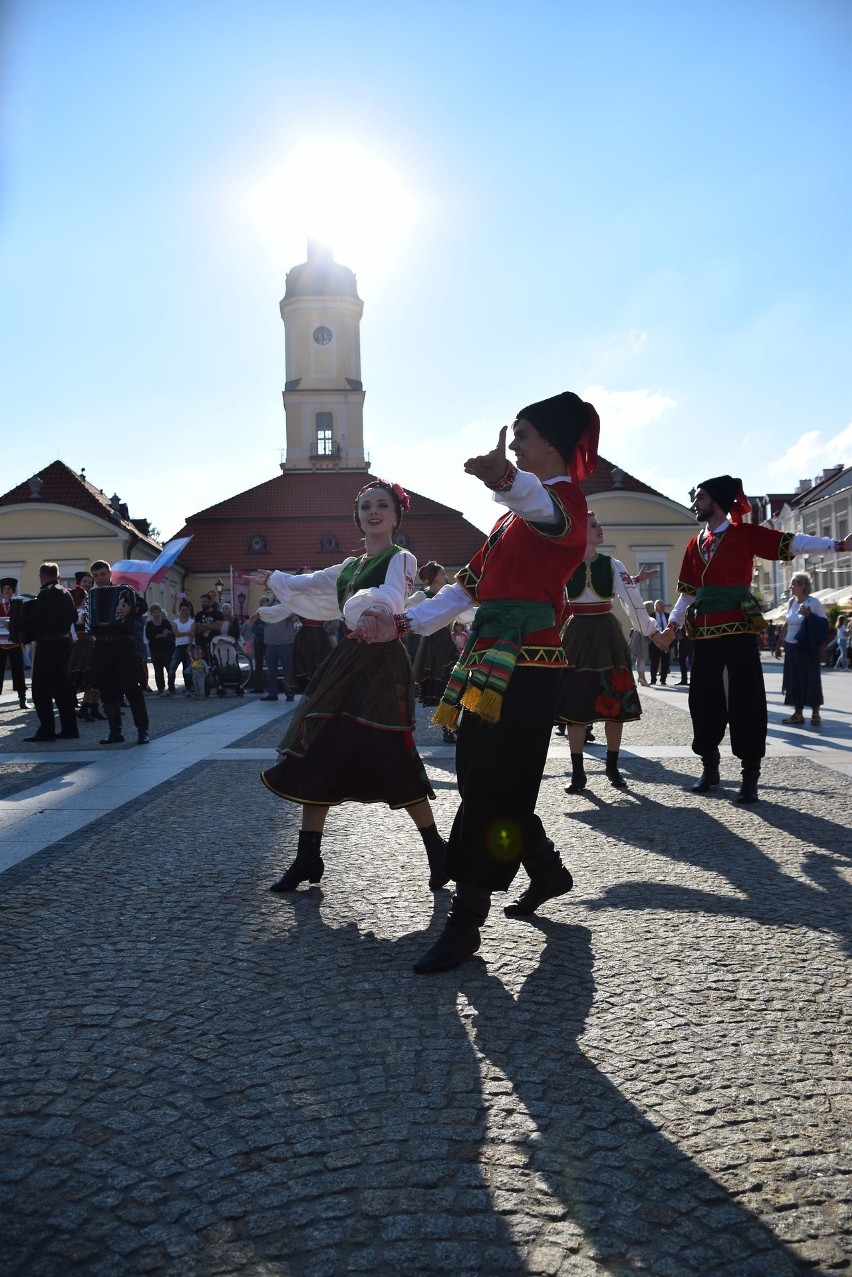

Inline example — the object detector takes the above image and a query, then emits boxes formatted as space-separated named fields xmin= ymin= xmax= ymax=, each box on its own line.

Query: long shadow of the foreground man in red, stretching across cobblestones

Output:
xmin=459 ymin=917 xmax=801 ymax=1277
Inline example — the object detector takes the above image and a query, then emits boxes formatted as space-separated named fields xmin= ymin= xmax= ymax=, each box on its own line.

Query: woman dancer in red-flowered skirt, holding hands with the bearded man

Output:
xmin=556 ymin=511 xmax=657 ymax=794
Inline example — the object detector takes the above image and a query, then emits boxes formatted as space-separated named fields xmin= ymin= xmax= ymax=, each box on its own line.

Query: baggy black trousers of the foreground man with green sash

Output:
xmin=447 ymin=665 xmax=562 ymax=891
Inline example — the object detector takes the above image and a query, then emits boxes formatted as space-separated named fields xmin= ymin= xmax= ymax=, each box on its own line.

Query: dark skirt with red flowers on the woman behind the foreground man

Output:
xmin=554 ymin=612 xmax=643 ymax=725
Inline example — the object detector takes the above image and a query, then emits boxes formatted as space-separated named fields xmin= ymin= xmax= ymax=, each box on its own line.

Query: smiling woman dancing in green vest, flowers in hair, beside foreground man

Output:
xmin=258 ymin=479 xmax=447 ymax=891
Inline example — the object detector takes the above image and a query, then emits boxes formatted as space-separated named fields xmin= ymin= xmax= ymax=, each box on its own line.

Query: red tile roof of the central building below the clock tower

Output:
xmin=169 ymin=470 xmax=483 ymax=572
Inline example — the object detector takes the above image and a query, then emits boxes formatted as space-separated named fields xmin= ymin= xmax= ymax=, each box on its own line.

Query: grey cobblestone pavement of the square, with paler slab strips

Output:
xmin=0 ymin=672 xmax=852 ymax=1277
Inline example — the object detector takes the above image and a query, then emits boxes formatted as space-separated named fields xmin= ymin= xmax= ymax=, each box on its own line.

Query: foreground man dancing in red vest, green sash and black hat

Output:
xmin=355 ymin=392 xmax=599 ymax=974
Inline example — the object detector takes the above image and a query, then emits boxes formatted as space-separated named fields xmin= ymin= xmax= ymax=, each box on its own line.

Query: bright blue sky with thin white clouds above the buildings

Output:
xmin=0 ymin=0 xmax=852 ymax=535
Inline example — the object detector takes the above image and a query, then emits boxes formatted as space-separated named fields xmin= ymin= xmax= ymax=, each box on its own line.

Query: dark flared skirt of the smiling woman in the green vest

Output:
xmin=261 ymin=639 xmax=434 ymax=807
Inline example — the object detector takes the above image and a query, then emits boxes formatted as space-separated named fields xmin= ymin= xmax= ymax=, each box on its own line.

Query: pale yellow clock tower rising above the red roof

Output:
xmin=281 ymin=240 xmax=367 ymax=472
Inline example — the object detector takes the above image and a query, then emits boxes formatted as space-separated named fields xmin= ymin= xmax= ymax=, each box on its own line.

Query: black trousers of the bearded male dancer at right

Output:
xmin=690 ymin=635 xmax=766 ymax=760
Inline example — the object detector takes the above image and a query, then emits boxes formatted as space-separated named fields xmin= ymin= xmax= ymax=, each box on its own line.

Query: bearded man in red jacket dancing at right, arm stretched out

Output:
xmin=654 ymin=475 xmax=852 ymax=803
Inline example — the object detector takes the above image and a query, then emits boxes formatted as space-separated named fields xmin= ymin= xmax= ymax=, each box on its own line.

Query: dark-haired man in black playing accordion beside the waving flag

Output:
xmin=91 ymin=559 xmax=151 ymax=744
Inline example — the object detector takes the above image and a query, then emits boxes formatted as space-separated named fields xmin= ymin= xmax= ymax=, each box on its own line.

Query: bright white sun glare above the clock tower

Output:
xmin=241 ymin=139 xmax=416 ymax=275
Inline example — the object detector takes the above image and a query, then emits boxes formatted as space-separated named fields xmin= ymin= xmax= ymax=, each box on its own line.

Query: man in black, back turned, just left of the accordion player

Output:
xmin=23 ymin=563 xmax=80 ymax=741
